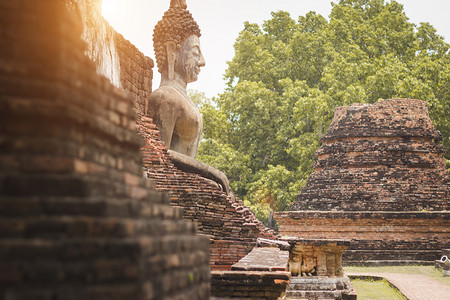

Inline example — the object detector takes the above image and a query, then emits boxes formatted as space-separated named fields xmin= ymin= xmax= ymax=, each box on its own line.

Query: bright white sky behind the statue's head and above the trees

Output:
xmin=103 ymin=0 xmax=450 ymax=97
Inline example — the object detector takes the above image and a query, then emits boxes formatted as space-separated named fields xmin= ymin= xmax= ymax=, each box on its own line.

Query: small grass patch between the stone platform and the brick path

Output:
xmin=352 ymin=279 xmax=407 ymax=300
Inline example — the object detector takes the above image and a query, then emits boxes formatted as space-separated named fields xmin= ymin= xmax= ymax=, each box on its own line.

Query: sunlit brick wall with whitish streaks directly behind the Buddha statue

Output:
xmin=67 ymin=0 xmax=154 ymax=115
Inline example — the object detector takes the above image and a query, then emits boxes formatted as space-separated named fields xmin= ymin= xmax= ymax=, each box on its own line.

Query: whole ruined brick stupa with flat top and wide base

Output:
xmin=276 ymin=99 xmax=450 ymax=263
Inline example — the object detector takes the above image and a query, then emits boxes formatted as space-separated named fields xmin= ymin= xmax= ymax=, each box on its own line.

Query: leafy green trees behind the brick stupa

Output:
xmin=197 ymin=0 xmax=450 ymax=223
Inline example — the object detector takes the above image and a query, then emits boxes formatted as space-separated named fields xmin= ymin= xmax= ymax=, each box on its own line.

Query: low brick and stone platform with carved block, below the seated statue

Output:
xmin=211 ymin=238 xmax=356 ymax=300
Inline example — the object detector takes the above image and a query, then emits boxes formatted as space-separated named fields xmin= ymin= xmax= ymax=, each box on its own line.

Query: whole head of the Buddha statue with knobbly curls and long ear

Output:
xmin=153 ymin=0 xmax=205 ymax=83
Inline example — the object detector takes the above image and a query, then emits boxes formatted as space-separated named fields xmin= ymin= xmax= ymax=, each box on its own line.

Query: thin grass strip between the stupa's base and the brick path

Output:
xmin=344 ymin=266 xmax=450 ymax=285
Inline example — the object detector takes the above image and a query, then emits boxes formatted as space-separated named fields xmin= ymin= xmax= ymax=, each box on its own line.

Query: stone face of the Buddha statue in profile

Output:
xmin=175 ymin=34 xmax=205 ymax=83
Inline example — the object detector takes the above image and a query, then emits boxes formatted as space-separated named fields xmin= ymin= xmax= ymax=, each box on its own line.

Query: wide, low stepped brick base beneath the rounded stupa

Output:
xmin=277 ymin=211 xmax=450 ymax=265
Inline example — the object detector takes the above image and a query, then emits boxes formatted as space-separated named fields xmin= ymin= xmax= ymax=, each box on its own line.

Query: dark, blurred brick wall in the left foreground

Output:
xmin=0 ymin=0 xmax=209 ymax=300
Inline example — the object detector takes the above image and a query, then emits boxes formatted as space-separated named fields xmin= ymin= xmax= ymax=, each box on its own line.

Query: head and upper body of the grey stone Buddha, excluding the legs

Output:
xmin=147 ymin=0 xmax=205 ymax=157
